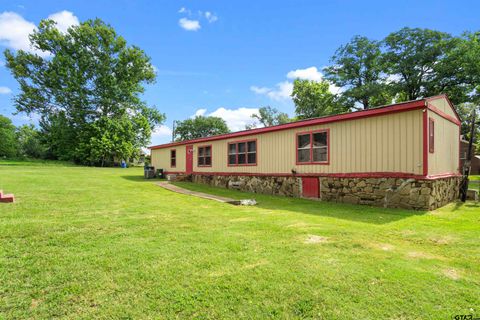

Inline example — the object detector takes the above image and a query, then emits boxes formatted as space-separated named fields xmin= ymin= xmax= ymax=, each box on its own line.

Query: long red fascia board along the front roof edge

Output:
xmin=149 ymin=99 xmax=426 ymax=150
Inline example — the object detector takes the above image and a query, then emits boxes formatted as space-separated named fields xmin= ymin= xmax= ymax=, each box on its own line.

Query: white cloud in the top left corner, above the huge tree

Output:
xmin=0 ymin=11 xmax=78 ymax=57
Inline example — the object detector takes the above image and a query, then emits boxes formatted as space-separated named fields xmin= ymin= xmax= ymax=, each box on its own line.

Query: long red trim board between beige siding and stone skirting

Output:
xmin=166 ymin=171 xmax=461 ymax=180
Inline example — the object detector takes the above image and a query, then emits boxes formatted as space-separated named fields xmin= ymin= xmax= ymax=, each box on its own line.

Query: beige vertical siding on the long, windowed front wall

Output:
xmin=176 ymin=110 xmax=423 ymax=174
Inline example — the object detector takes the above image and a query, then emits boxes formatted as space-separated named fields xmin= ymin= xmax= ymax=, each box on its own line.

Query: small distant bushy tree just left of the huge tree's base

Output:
xmin=17 ymin=125 xmax=46 ymax=159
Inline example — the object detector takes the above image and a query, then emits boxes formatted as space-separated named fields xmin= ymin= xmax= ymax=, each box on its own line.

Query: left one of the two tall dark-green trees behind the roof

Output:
xmin=324 ymin=36 xmax=392 ymax=109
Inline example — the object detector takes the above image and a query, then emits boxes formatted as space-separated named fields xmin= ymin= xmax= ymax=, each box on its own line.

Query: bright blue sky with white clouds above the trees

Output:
xmin=0 ymin=0 xmax=480 ymax=144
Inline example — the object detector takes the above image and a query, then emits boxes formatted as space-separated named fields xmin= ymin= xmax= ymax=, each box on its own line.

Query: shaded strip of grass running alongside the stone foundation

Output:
xmin=175 ymin=182 xmax=427 ymax=225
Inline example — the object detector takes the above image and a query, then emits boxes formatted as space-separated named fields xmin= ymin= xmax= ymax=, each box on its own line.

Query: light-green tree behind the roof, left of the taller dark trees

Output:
xmin=292 ymin=79 xmax=348 ymax=119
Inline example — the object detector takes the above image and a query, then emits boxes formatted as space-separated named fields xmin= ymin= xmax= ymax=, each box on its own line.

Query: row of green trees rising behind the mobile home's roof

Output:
xmin=177 ymin=28 xmax=480 ymax=148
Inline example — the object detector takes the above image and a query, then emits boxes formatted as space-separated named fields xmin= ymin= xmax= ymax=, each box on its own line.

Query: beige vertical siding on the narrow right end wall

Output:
xmin=428 ymin=107 xmax=460 ymax=175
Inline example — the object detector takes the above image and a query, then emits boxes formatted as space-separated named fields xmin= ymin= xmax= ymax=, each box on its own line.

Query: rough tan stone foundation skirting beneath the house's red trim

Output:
xmin=186 ymin=174 xmax=461 ymax=210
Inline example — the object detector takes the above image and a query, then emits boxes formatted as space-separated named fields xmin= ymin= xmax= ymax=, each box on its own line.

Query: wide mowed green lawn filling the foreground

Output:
xmin=0 ymin=162 xmax=480 ymax=319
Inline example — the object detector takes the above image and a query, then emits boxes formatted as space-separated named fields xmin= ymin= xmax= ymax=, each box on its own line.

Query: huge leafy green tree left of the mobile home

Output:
xmin=5 ymin=19 xmax=165 ymax=165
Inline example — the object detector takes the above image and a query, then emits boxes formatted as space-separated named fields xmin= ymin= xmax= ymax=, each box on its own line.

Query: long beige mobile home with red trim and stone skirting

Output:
xmin=150 ymin=95 xmax=460 ymax=210
